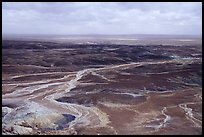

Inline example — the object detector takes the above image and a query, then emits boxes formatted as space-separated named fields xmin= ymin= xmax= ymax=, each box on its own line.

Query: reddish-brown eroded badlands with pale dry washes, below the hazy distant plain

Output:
xmin=2 ymin=41 xmax=202 ymax=135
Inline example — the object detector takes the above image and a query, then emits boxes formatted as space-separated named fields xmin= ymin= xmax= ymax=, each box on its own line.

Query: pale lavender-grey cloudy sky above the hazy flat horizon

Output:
xmin=2 ymin=2 xmax=202 ymax=35
